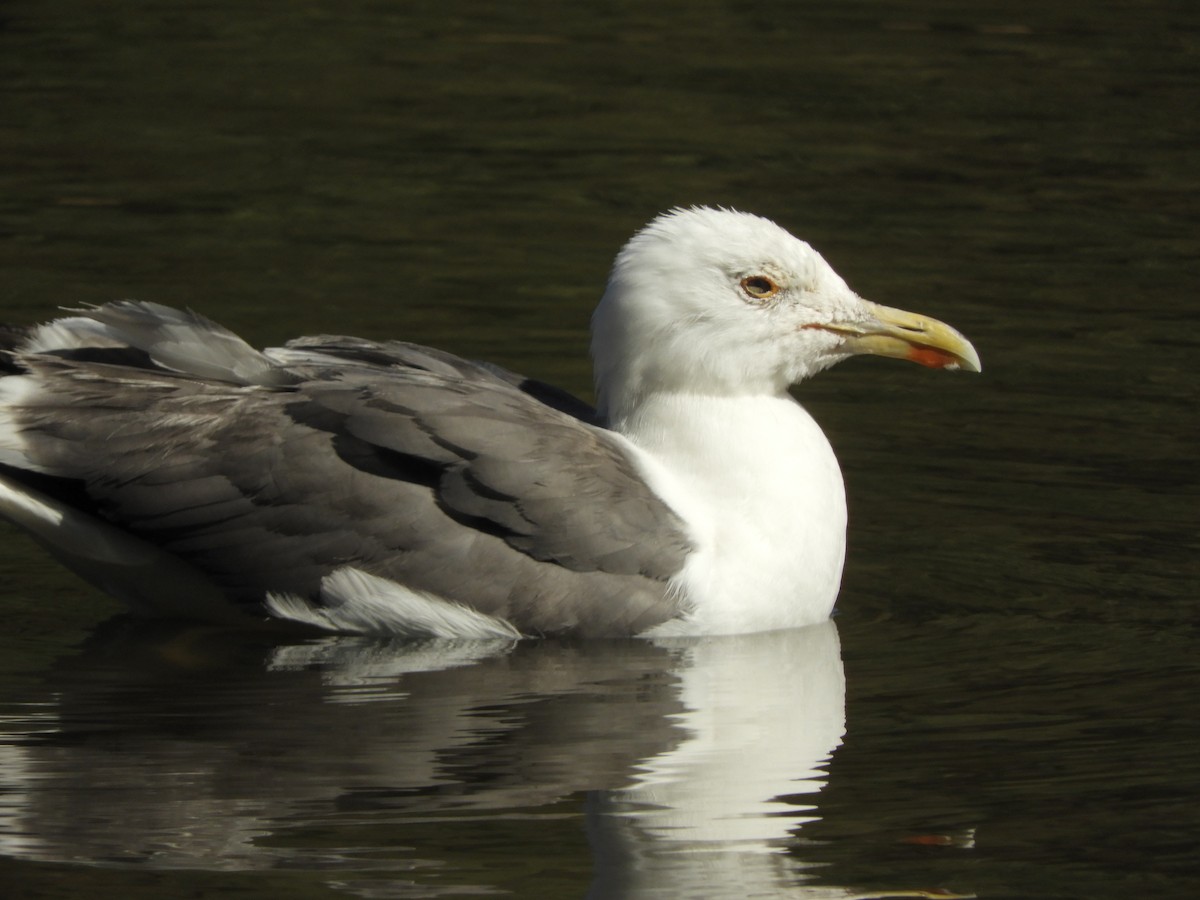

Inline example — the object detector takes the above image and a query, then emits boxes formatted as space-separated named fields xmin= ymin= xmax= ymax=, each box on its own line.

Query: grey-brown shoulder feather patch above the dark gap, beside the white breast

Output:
xmin=304 ymin=377 xmax=689 ymax=581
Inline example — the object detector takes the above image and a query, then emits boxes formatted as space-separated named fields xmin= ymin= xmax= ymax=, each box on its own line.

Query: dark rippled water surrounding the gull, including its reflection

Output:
xmin=0 ymin=0 xmax=1200 ymax=900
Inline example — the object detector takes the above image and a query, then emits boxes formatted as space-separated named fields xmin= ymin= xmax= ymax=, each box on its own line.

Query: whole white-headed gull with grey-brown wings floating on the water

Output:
xmin=0 ymin=208 xmax=979 ymax=640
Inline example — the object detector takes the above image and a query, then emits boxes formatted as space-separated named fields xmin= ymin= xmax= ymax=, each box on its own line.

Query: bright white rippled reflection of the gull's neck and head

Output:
xmin=592 ymin=622 xmax=853 ymax=898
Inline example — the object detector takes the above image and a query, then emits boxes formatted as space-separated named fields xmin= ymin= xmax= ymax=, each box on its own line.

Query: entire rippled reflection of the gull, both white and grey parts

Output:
xmin=0 ymin=623 xmax=864 ymax=898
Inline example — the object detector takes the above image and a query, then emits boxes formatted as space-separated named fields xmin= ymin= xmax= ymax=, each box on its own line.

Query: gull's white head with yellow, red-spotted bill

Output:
xmin=592 ymin=208 xmax=979 ymax=424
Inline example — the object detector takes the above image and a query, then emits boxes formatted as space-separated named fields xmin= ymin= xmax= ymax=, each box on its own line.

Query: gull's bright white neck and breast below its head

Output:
xmin=617 ymin=392 xmax=846 ymax=635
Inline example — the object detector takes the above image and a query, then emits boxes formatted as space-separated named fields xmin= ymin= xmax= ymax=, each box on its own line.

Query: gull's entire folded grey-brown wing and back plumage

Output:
xmin=4 ymin=305 xmax=690 ymax=635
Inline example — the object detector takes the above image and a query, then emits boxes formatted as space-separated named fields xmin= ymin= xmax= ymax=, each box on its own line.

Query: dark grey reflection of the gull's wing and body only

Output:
xmin=0 ymin=629 xmax=679 ymax=872
